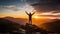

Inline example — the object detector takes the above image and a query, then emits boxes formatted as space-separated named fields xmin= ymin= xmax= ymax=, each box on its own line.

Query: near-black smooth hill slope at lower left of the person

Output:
xmin=0 ymin=18 xmax=22 ymax=32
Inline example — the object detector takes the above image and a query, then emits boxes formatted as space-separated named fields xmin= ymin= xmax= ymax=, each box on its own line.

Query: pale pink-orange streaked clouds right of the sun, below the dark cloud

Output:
xmin=35 ymin=12 xmax=60 ymax=19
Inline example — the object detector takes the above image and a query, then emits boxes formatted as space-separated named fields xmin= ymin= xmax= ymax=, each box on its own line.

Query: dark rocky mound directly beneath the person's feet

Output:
xmin=25 ymin=23 xmax=47 ymax=34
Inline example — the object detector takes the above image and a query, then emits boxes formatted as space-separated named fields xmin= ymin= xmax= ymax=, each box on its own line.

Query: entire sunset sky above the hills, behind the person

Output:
xmin=0 ymin=0 xmax=60 ymax=19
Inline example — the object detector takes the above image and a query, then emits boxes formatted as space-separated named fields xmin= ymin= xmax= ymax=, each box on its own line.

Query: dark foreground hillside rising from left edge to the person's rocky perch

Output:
xmin=0 ymin=18 xmax=47 ymax=34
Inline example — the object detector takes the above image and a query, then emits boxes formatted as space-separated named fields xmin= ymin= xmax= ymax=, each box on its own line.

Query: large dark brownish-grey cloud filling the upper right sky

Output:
xmin=26 ymin=0 xmax=60 ymax=12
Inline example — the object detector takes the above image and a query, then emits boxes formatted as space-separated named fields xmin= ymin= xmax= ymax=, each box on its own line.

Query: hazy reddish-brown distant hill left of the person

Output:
xmin=4 ymin=17 xmax=27 ymax=25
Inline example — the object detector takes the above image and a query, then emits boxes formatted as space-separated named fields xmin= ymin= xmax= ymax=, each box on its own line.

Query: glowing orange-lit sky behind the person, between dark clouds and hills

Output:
xmin=0 ymin=4 xmax=60 ymax=25
